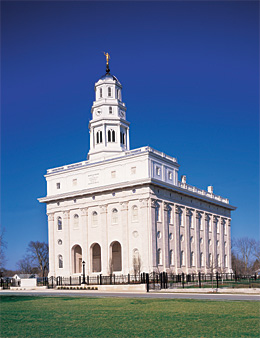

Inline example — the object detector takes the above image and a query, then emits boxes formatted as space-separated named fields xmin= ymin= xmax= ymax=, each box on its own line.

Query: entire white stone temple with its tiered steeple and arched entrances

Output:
xmin=39 ymin=56 xmax=236 ymax=277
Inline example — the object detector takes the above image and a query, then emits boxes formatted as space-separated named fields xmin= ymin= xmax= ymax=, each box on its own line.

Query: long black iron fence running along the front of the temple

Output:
xmin=0 ymin=272 xmax=260 ymax=291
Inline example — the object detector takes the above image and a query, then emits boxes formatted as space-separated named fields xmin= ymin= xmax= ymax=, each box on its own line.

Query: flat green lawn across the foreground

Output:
xmin=0 ymin=296 xmax=260 ymax=338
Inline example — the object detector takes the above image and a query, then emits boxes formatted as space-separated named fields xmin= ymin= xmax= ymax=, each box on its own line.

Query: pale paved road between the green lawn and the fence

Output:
xmin=0 ymin=290 xmax=260 ymax=301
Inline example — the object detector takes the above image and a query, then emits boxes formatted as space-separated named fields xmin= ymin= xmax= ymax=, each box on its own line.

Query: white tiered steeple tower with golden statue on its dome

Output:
xmin=88 ymin=53 xmax=130 ymax=161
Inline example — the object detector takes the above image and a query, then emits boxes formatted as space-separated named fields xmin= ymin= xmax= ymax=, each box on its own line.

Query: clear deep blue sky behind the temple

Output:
xmin=1 ymin=1 xmax=259 ymax=268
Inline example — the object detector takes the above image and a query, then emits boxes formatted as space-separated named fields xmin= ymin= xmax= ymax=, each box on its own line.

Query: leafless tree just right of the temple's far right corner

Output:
xmin=234 ymin=237 xmax=255 ymax=274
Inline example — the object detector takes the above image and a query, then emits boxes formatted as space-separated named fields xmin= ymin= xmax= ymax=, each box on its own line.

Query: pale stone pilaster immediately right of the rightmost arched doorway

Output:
xmin=120 ymin=202 xmax=129 ymax=275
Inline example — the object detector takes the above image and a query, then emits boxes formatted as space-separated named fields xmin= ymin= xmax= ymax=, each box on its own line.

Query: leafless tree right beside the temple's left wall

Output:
xmin=27 ymin=241 xmax=49 ymax=277
